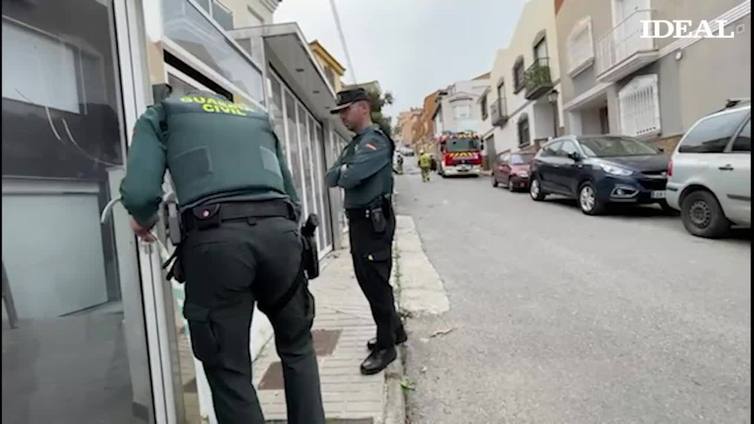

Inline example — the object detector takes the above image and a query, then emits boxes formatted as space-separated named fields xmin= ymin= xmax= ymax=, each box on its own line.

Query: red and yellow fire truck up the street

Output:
xmin=435 ymin=132 xmax=482 ymax=178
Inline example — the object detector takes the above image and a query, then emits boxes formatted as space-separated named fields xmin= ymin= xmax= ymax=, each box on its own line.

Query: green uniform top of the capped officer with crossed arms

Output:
xmin=325 ymin=126 xmax=393 ymax=209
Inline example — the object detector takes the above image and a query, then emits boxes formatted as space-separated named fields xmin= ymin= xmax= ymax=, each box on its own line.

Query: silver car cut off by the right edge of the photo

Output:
xmin=666 ymin=99 xmax=751 ymax=238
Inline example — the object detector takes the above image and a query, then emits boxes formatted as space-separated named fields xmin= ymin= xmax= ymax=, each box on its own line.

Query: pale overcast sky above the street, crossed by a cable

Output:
xmin=274 ymin=0 xmax=525 ymax=116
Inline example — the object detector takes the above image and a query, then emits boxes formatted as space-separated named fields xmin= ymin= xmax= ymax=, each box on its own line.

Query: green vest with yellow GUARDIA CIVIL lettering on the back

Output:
xmin=162 ymin=92 xmax=285 ymax=205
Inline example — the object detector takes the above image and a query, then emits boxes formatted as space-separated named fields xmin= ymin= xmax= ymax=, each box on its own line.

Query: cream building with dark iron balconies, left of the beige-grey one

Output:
xmin=487 ymin=0 xmax=562 ymax=154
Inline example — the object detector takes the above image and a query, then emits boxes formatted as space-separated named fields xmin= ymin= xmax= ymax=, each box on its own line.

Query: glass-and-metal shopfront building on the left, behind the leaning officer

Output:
xmin=2 ymin=0 xmax=349 ymax=423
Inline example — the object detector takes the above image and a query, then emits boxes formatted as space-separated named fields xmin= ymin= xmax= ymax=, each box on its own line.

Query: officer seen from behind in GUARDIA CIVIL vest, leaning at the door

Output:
xmin=120 ymin=91 xmax=325 ymax=424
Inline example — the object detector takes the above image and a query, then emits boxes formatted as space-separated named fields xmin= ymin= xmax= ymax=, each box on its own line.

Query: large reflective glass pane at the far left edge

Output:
xmin=2 ymin=0 xmax=154 ymax=423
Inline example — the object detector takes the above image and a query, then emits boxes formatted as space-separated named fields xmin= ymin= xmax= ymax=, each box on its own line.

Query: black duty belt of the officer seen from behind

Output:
xmin=181 ymin=199 xmax=296 ymax=232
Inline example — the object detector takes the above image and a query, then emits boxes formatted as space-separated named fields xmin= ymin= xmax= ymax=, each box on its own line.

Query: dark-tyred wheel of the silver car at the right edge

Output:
xmin=681 ymin=190 xmax=730 ymax=238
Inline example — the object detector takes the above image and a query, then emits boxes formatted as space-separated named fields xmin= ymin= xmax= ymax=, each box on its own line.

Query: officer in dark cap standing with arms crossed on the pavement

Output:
xmin=326 ymin=88 xmax=407 ymax=375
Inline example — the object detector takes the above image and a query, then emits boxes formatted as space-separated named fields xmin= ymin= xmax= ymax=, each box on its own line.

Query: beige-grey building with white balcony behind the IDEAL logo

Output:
xmin=555 ymin=0 xmax=751 ymax=152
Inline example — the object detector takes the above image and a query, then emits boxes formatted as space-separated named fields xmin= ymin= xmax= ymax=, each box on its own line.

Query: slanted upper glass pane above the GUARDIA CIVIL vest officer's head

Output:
xmin=162 ymin=0 xmax=265 ymax=105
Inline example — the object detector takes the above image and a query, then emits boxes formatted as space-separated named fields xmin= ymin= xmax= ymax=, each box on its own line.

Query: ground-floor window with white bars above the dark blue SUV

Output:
xmin=618 ymin=74 xmax=661 ymax=136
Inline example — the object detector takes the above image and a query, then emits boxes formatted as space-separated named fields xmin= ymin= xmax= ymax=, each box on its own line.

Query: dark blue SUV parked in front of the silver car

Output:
xmin=529 ymin=135 xmax=672 ymax=215
